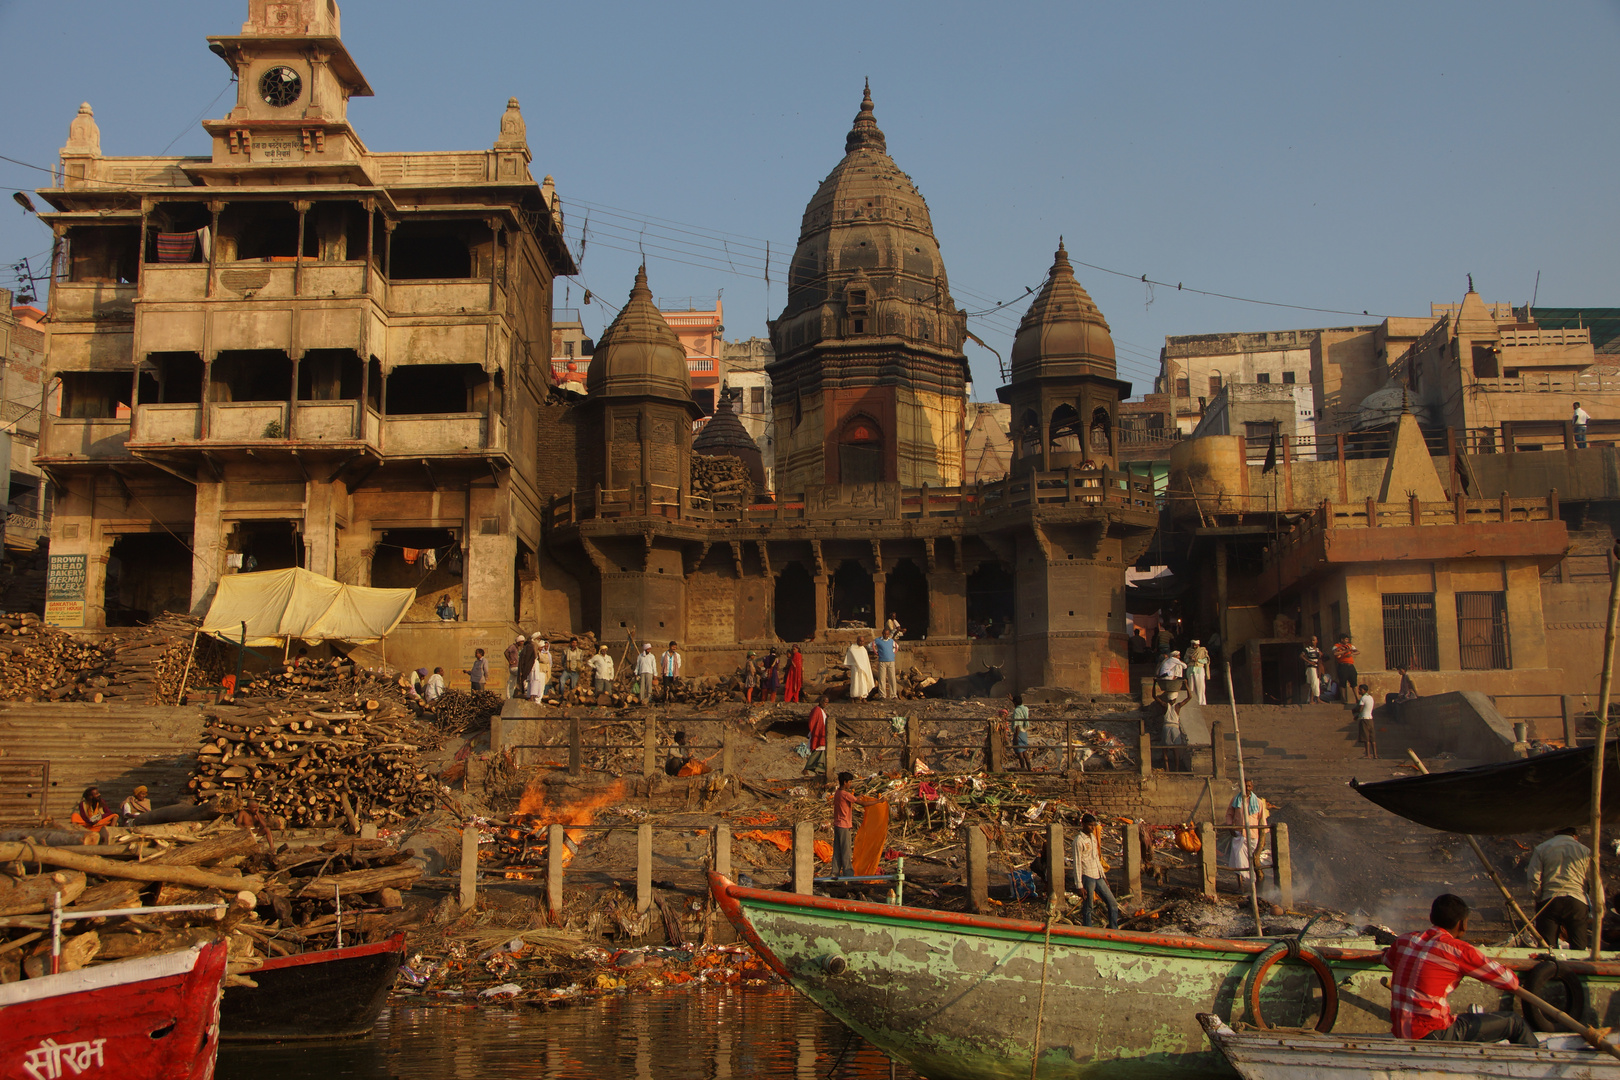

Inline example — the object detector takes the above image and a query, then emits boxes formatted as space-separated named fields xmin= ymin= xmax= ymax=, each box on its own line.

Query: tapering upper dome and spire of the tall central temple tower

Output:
xmin=773 ymin=86 xmax=967 ymax=358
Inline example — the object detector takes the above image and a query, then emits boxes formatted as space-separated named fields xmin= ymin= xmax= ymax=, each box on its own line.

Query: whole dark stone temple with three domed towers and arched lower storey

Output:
xmin=541 ymin=94 xmax=1155 ymax=691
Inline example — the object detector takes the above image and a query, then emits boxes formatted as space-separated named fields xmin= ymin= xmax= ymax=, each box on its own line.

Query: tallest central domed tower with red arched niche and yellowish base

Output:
xmin=766 ymin=86 xmax=967 ymax=492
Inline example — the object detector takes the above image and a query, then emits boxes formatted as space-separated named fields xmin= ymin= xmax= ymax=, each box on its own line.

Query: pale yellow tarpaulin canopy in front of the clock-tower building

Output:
xmin=203 ymin=567 xmax=416 ymax=648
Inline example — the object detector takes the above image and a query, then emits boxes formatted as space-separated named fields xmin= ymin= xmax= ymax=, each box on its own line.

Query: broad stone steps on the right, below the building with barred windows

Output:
xmin=1218 ymin=704 xmax=1526 ymax=934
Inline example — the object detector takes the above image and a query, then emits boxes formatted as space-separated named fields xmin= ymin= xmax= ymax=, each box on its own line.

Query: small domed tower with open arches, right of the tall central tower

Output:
xmin=996 ymin=238 xmax=1131 ymax=476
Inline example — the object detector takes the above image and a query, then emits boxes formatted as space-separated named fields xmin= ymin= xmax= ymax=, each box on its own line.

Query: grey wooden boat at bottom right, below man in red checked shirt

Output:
xmin=1199 ymin=1012 xmax=1620 ymax=1080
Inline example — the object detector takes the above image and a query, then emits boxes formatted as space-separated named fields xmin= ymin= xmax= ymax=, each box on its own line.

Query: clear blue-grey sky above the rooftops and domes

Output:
xmin=0 ymin=0 xmax=1620 ymax=400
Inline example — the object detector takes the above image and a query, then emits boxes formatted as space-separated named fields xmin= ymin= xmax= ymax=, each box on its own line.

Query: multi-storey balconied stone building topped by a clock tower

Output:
xmin=39 ymin=0 xmax=575 ymax=670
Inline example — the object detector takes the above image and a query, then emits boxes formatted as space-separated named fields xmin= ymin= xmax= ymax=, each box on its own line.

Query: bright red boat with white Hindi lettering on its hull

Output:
xmin=0 ymin=942 xmax=225 ymax=1080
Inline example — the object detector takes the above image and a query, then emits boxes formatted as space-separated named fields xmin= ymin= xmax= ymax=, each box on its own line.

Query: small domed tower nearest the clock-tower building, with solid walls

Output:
xmin=585 ymin=266 xmax=703 ymax=497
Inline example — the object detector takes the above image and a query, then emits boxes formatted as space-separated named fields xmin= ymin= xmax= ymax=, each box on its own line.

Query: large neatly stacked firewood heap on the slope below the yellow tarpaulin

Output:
xmin=190 ymin=698 xmax=441 ymax=832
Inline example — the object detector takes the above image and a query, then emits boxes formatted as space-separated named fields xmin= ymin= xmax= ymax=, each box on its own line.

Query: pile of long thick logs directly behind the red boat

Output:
xmin=0 ymin=821 xmax=421 ymax=983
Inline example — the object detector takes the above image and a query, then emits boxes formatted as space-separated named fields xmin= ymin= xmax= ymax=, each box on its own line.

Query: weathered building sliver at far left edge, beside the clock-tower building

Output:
xmin=0 ymin=288 xmax=53 ymax=552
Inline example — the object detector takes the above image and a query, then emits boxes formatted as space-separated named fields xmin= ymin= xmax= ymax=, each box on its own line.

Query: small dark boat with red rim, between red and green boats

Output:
xmin=220 ymin=934 xmax=405 ymax=1043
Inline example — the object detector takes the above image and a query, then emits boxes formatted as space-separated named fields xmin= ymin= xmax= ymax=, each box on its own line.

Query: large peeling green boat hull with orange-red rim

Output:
xmin=710 ymin=874 xmax=1620 ymax=1080
